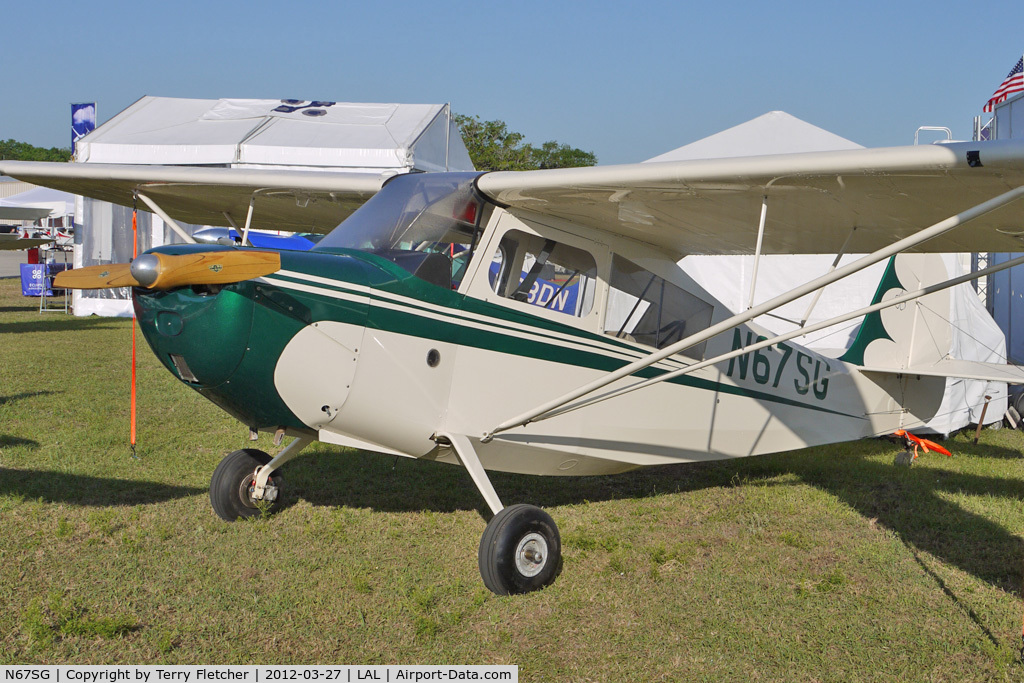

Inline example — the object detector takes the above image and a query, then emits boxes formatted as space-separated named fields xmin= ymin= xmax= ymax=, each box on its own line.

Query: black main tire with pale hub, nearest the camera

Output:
xmin=477 ymin=505 xmax=562 ymax=595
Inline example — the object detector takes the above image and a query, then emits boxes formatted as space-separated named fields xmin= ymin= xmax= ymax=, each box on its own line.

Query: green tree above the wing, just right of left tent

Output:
xmin=455 ymin=114 xmax=597 ymax=171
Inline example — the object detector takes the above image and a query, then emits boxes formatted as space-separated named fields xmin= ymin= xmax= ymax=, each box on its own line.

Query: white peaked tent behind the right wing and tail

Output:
xmin=648 ymin=112 xmax=1007 ymax=434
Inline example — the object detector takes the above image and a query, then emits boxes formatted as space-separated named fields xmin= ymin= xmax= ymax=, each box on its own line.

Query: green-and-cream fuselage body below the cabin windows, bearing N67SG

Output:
xmin=134 ymin=239 xmax=929 ymax=474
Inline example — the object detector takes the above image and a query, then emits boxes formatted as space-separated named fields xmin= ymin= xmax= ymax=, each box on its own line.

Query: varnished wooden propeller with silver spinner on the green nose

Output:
xmin=53 ymin=251 xmax=281 ymax=290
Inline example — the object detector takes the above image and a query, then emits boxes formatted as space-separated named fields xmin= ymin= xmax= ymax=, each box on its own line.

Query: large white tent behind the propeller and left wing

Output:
xmin=74 ymin=96 xmax=473 ymax=315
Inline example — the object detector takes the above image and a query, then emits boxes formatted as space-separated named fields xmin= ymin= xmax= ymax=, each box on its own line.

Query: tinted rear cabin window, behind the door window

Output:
xmin=604 ymin=255 xmax=714 ymax=360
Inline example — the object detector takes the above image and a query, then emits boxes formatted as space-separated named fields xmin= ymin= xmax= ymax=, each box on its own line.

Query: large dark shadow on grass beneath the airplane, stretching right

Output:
xmin=283 ymin=440 xmax=1024 ymax=592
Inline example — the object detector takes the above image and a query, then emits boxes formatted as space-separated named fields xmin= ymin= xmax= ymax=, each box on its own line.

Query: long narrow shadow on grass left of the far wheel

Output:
xmin=0 ymin=467 xmax=206 ymax=506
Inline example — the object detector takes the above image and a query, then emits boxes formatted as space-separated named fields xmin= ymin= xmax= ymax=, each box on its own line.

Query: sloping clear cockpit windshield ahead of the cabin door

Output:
xmin=312 ymin=173 xmax=483 ymax=288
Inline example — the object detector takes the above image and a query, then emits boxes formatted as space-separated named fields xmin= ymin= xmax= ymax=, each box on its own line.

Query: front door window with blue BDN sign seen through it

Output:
xmin=487 ymin=230 xmax=597 ymax=317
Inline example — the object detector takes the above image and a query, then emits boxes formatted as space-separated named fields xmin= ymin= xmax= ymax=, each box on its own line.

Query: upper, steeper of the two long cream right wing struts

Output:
xmin=482 ymin=186 xmax=1024 ymax=443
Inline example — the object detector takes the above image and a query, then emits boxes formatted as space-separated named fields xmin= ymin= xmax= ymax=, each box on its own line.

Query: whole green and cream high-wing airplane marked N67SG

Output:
xmin=6 ymin=140 xmax=1024 ymax=594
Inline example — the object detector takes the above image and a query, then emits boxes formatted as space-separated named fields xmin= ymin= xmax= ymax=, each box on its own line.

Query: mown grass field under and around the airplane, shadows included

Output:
xmin=0 ymin=280 xmax=1024 ymax=681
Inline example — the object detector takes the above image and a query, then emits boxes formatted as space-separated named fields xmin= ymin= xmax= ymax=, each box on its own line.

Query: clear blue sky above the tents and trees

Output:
xmin=8 ymin=0 xmax=1024 ymax=164
